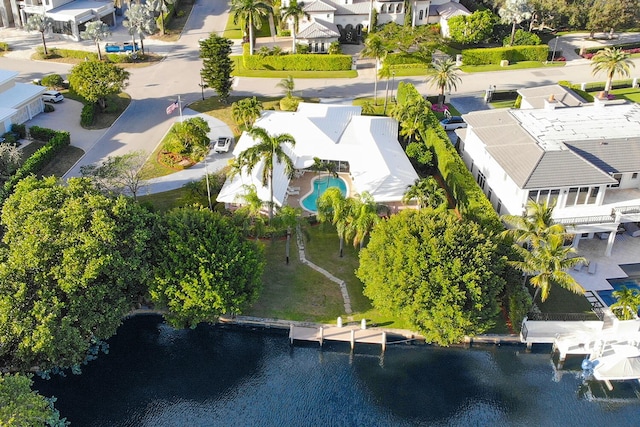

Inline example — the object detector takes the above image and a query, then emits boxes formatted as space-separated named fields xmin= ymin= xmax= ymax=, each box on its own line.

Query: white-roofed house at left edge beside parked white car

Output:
xmin=0 ymin=70 xmax=47 ymax=135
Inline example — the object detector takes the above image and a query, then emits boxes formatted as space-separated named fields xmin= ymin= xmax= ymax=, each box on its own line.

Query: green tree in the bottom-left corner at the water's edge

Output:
xmin=0 ymin=374 xmax=66 ymax=427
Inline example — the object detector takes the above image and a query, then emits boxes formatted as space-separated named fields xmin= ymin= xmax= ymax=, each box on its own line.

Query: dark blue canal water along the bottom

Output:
xmin=36 ymin=316 xmax=640 ymax=427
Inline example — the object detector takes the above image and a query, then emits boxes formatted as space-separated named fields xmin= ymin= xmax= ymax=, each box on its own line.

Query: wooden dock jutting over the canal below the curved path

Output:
xmin=289 ymin=325 xmax=387 ymax=351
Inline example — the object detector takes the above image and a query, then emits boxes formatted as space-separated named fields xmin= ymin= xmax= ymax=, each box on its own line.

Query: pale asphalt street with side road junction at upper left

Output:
xmin=0 ymin=6 xmax=640 ymax=187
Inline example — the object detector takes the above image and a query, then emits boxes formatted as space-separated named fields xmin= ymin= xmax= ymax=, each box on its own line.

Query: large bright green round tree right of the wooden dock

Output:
xmin=356 ymin=209 xmax=506 ymax=345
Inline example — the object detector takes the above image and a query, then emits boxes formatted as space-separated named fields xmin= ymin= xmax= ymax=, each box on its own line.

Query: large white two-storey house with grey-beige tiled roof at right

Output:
xmin=460 ymin=85 xmax=640 ymax=254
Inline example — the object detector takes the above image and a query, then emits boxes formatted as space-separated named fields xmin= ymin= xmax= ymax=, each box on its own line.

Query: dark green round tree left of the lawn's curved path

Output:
xmin=150 ymin=208 xmax=264 ymax=327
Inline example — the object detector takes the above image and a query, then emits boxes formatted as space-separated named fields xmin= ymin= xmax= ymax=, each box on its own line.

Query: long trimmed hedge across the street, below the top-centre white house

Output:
xmin=243 ymin=43 xmax=351 ymax=71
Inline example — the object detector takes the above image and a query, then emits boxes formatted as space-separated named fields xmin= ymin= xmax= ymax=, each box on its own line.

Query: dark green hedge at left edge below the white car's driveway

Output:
xmin=2 ymin=126 xmax=71 ymax=200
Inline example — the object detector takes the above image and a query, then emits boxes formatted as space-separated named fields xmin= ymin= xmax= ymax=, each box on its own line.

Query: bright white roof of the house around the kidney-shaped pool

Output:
xmin=217 ymin=103 xmax=418 ymax=212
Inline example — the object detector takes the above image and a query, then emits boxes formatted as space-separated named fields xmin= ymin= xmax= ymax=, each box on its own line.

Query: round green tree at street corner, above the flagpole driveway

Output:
xmin=69 ymin=61 xmax=129 ymax=109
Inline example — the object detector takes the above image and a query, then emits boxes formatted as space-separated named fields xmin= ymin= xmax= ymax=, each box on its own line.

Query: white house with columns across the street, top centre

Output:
xmin=282 ymin=0 xmax=470 ymax=53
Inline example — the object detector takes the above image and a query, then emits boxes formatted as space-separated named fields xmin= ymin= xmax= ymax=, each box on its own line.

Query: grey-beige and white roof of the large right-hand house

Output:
xmin=464 ymin=103 xmax=640 ymax=189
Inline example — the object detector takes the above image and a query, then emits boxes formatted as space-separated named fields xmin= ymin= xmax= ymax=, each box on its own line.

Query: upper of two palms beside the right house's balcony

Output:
xmin=501 ymin=200 xmax=566 ymax=248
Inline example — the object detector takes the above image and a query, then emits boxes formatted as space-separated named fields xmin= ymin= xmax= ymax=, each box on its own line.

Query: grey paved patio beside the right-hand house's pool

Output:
xmin=569 ymin=233 xmax=640 ymax=291
